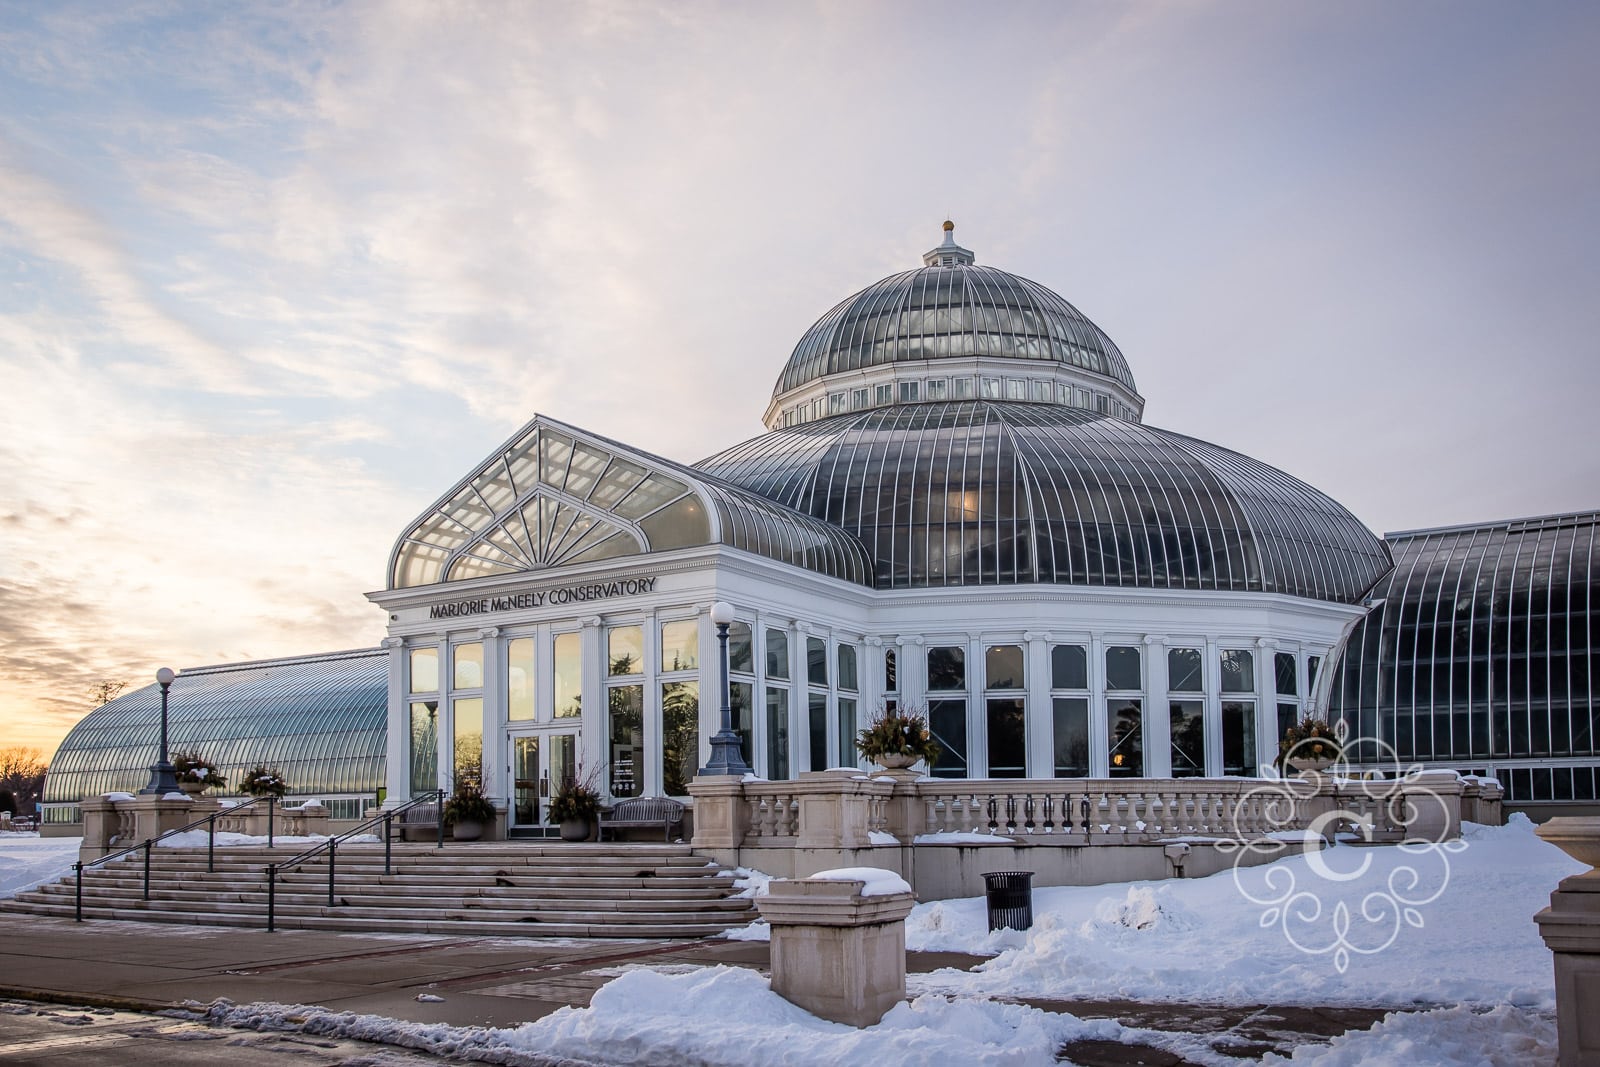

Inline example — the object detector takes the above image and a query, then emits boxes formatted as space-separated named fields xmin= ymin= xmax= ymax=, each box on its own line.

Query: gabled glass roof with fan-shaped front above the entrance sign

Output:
xmin=389 ymin=416 xmax=872 ymax=589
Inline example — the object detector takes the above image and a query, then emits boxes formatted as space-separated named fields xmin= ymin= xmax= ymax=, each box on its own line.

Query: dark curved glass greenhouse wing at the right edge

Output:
xmin=1330 ymin=512 xmax=1600 ymax=764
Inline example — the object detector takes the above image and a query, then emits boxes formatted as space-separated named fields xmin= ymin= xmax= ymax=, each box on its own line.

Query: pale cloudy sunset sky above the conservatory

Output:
xmin=0 ymin=0 xmax=1600 ymax=755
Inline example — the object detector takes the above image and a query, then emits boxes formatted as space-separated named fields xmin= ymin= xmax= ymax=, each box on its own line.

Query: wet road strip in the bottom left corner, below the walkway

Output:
xmin=0 ymin=1000 xmax=453 ymax=1067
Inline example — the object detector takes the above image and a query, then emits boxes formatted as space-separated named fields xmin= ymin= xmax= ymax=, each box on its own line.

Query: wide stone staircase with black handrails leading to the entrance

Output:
xmin=0 ymin=843 xmax=757 ymax=937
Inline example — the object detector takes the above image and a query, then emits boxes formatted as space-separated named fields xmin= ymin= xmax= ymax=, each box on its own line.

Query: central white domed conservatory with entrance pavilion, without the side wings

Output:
xmin=370 ymin=224 xmax=1390 ymax=832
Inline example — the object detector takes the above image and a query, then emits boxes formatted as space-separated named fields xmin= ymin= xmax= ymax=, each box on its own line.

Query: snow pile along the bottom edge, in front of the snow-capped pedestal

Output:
xmin=206 ymin=966 xmax=1113 ymax=1067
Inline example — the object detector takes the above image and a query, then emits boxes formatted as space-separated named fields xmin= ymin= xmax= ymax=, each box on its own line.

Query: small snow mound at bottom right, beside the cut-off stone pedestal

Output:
xmin=1261 ymin=1005 xmax=1557 ymax=1067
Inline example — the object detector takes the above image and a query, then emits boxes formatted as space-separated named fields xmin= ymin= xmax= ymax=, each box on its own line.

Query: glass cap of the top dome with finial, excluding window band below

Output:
xmin=773 ymin=231 xmax=1138 ymax=397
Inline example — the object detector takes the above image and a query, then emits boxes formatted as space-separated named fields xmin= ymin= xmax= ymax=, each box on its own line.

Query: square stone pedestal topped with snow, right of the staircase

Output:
xmin=755 ymin=880 xmax=912 ymax=1027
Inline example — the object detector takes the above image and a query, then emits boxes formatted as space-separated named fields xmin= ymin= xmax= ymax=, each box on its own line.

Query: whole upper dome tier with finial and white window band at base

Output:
xmin=766 ymin=221 xmax=1144 ymax=429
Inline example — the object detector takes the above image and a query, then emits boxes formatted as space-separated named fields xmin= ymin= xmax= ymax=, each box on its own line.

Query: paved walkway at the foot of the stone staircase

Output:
xmin=0 ymin=915 xmax=982 ymax=1027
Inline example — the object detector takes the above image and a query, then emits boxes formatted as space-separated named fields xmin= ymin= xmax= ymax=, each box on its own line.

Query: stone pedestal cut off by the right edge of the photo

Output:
xmin=1533 ymin=816 xmax=1600 ymax=1067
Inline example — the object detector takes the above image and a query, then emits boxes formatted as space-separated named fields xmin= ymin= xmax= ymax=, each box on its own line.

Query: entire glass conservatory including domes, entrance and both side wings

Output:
xmin=45 ymin=222 xmax=1600 ymax=835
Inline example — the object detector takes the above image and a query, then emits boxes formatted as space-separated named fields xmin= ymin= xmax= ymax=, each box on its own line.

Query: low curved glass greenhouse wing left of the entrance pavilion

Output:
xmin=43 ymin=649 xmax=389 ymax=803
